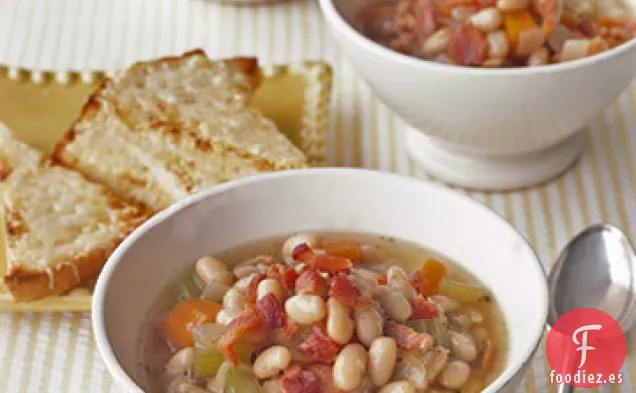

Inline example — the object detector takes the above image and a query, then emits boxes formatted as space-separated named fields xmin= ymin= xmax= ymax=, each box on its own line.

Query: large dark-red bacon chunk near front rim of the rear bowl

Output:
xmin=446 ymin=23 xmax=488 ymax=66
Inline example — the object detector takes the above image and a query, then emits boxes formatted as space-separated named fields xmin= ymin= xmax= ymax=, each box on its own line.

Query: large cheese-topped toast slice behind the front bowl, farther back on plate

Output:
xmin=53 ymin=51 xmax=307 ymax=211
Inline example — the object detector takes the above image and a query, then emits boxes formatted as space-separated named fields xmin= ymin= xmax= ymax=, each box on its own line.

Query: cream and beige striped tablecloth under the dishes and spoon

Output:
xmin=0 ymin=0 xmax=636 ymax=393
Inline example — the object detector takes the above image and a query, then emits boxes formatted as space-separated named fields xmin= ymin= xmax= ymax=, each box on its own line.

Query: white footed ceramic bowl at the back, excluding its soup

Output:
xmin=320 ymin=0 xmax=636 ymax=189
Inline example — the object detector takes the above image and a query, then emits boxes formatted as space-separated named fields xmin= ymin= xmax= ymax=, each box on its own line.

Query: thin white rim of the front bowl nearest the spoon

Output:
xmin=91 ymin=167 xmax=549 ymax=393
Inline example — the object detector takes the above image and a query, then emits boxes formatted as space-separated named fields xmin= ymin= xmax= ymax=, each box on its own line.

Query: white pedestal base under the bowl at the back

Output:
xmin=405 ymin=128 xmax=585 ymax=191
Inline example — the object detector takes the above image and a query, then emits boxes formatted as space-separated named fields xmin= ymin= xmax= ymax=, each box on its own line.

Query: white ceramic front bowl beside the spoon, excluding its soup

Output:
xmin=92 ymin=169 xmax=548 ymax=393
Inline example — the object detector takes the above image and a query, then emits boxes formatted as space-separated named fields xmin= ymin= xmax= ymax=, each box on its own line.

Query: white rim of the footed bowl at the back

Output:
xmin=318 ymin=0 xmax=636 ymax=76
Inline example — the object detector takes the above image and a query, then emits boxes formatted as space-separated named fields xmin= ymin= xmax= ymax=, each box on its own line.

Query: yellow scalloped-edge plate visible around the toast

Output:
xmin=0 ymin=62 xmax=332 ymax=311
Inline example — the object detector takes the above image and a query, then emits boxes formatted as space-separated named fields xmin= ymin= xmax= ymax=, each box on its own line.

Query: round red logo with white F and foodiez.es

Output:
xmin=546 ymin=308 xmax=627 ymax=388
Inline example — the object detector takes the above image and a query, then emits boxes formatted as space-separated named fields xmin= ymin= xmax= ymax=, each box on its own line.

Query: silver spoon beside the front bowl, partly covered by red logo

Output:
xmin=548 ymin=224 xmax=636 ymax=393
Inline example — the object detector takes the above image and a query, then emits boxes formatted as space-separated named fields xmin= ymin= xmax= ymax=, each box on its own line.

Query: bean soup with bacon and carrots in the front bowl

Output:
xmin=139 ymin=233 xmax=508 ymax=393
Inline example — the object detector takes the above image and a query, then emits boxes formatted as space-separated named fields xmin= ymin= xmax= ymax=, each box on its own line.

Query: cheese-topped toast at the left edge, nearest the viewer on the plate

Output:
xmin=0 ymin=124 xmax=147 ymax=302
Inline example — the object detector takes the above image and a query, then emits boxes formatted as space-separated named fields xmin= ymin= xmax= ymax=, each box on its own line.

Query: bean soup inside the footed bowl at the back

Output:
xmin=354 ymin=0 xmax=636 ymax=67
